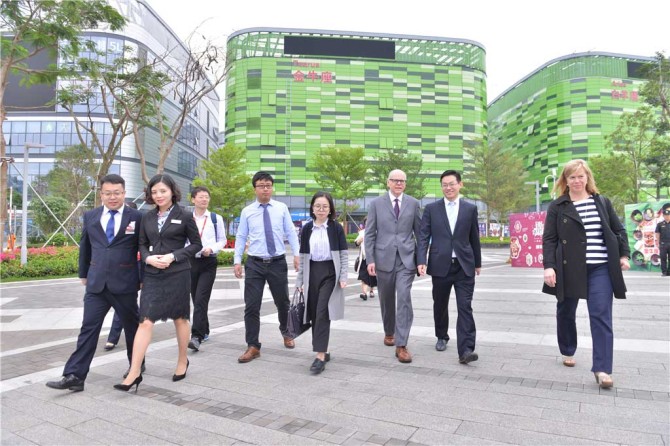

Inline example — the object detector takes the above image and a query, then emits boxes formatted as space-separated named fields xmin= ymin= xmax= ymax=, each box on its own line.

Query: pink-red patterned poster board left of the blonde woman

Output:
xmin=509 ymin=211 xmax=547 ymax=268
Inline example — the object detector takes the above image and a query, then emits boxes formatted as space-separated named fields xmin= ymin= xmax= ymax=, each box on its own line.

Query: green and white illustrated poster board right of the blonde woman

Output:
xmin=624 ymin=201 xmax=670 ymax=272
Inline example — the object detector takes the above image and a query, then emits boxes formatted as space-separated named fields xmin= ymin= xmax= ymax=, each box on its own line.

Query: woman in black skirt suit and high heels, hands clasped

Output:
xmin=114 ymin=174 xmax=202 ymax=391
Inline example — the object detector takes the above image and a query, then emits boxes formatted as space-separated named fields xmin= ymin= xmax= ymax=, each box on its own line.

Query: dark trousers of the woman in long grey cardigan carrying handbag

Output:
xmin=307 ymin=260 xmax=336 ymax=352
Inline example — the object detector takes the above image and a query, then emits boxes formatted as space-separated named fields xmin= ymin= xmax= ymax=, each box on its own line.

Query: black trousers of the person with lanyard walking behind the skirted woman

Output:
xmin=191 ymin=257 xmax=217 ymax=341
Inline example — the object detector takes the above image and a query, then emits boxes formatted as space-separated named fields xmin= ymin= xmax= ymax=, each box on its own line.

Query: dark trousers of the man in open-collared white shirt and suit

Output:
xmin=433 ymin=261 xmax=477 ymax=357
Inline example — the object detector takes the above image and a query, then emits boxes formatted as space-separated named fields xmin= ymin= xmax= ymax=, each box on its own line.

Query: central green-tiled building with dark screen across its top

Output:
xmin=225 ymin=28 xmax=487 ymax=209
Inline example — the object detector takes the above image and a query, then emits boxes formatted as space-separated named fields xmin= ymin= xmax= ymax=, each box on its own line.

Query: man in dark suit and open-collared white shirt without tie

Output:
xmin=417 ymin=170 xmax=482 ymax=364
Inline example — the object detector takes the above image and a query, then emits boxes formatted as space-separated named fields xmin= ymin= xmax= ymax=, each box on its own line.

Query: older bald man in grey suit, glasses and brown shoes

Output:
xmin=365 ymin=170 xmax=421 ymax=363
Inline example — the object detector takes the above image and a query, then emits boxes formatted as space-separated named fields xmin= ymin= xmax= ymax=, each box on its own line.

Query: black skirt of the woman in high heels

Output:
xmin=140 ymin=269 xmax=191 ymax=322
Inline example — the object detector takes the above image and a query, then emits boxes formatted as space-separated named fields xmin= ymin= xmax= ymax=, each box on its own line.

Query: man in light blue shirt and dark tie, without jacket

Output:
xmin=234 ymin=172 xmax=300 ymax=363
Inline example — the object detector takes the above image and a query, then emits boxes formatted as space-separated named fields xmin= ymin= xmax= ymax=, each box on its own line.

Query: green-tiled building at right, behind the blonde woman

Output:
xmin=488 ymin=52 xmax=653 ymax=202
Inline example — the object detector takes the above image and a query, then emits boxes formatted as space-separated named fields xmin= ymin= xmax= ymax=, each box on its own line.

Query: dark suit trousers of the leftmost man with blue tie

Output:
xmin=63 ymin=287 xmax=139 ymax=379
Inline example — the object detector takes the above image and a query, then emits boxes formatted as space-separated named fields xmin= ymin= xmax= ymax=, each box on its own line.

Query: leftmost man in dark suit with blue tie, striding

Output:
xmin=47 ymin=174 xmax=142 ymax=391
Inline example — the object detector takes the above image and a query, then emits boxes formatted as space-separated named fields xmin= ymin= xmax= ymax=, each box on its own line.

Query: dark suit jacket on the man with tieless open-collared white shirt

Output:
xmin=417 ymin=199 xmax=482 ymax=277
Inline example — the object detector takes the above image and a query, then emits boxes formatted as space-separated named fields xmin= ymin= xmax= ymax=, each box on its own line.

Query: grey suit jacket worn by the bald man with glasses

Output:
xmin=365 ymin=193 xmax=421 ymax=272
